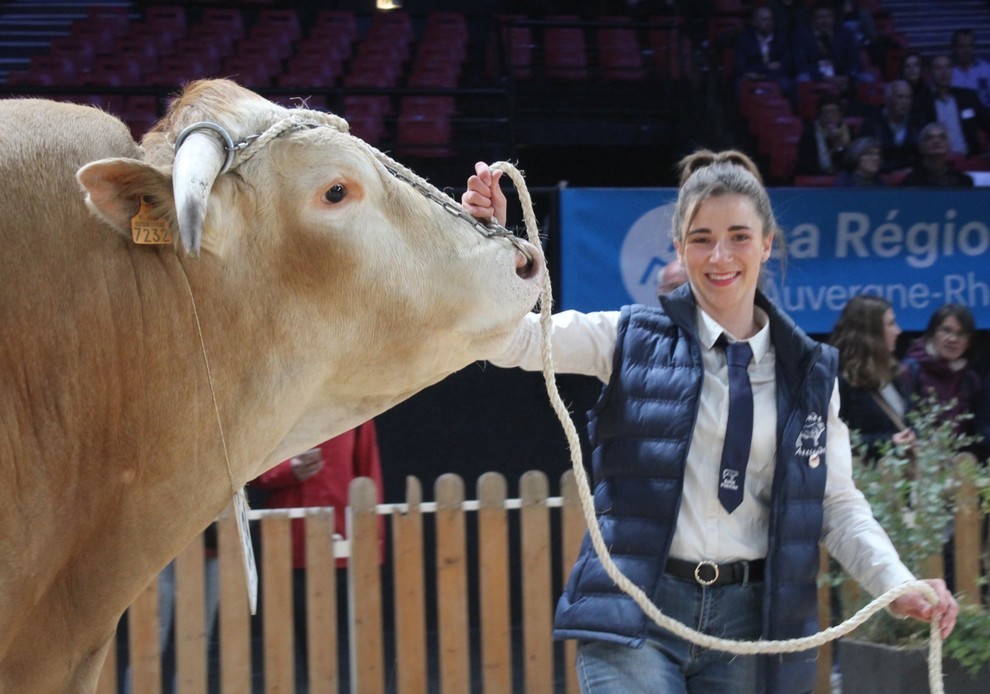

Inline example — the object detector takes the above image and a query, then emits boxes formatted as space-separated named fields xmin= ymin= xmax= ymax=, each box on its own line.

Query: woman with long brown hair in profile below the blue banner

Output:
xmin=829 ymin=296 xmax=914 ymax=459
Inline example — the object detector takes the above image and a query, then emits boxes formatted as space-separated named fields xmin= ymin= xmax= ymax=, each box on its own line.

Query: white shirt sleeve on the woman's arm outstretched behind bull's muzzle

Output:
xmin=491 ymin=311 xmax=619 ymax=383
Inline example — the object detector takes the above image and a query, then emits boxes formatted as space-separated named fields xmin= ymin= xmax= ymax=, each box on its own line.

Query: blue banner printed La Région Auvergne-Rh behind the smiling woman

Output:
xmin=558 ymin=188 xmax=990 ymax=333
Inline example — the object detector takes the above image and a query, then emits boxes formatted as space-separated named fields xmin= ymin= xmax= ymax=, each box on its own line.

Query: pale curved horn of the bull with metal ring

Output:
xmin=172 ymin=123 xmax=233 ymax=257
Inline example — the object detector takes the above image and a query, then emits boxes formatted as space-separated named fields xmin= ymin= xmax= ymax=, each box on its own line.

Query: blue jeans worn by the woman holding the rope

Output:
xmin=577 ymin=576 xmax=763 ymax=694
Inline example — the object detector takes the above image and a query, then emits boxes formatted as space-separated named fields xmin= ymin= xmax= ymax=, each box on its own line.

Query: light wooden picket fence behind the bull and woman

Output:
xmin=98 ymin=472 xmax=984 ymax=694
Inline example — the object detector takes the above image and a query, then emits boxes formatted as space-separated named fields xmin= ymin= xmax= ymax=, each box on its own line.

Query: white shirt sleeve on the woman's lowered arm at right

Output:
xmin=822 ymin=385 xmax=915 ymax=597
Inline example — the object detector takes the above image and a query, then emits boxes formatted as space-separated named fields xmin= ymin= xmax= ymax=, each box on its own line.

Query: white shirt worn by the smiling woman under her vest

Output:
xmin=492 ymin=309 xmax=914 ymax=595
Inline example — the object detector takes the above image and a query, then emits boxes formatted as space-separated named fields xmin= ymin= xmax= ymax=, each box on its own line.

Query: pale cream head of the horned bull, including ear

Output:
xmin=78 ymin=80 xmax=543 ymax=474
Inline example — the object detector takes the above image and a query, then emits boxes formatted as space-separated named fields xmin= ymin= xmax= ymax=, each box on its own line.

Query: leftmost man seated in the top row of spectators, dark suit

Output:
xmin=735 ymin=6 xmax=794 ymax=100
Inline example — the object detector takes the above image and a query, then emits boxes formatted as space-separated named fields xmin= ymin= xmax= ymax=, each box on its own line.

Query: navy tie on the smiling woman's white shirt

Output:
xmin=718 ymin=336 xmax=753 ymax=513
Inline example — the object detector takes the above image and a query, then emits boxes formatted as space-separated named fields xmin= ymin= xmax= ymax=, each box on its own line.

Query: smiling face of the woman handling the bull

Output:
xmin=674 ymin=194 xmax=773 ymax=337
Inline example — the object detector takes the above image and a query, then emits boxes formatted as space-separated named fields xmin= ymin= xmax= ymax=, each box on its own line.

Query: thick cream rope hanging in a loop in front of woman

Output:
xmin=491 ymin=161 xmax=944 ymax=694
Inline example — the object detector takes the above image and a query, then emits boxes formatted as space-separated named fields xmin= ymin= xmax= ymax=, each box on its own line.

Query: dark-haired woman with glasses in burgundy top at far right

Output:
xmin=902 ymin=304 xmax=983 ymax=433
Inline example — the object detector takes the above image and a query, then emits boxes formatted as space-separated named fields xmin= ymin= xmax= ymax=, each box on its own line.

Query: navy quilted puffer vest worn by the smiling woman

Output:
xmin=554 ymin=286 xmax=838 ymax=694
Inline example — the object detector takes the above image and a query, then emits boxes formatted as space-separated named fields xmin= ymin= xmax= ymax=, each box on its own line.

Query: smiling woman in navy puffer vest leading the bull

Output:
xmin=462 ymin=151 xmax=958 ymax=694
